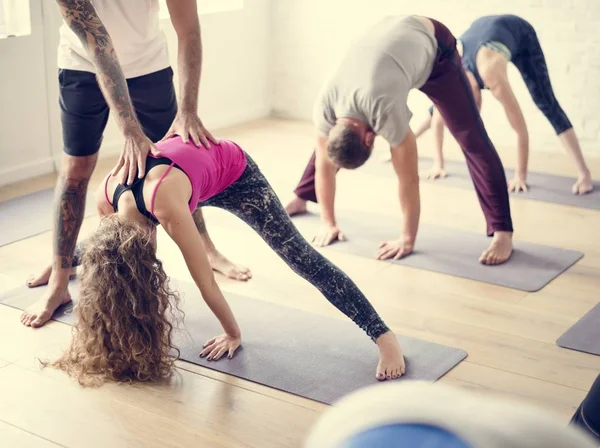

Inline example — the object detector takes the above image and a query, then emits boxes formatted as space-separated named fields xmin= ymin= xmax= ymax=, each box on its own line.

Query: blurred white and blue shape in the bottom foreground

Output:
xmin=304 ymin=380 xmax=600 ymax=448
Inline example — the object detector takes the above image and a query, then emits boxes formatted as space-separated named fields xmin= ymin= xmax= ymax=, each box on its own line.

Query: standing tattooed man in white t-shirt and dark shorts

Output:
xmin=21 ymin=0 xmax=251 ymax=327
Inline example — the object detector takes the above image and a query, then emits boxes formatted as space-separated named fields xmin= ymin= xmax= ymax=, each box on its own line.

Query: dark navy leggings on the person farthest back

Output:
xmin=512 ymin=26 xmax=573 ymax=135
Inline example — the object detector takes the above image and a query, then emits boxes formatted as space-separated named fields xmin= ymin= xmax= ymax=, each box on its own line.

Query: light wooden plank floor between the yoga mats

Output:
xmin=0 ymin=120 xmax=600 ymax=448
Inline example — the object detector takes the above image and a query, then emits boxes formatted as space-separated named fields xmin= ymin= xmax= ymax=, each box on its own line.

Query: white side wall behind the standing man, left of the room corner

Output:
xmin=0 ymin=0 xmax=270 ymax=185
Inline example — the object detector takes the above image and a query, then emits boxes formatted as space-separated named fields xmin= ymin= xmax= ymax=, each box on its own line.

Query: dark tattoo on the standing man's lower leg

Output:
xmin=54 ymin=178 xmax=89 ymax=269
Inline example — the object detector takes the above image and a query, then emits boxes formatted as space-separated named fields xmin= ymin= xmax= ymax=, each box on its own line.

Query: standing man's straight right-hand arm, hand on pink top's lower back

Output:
xmin=164 ymin=0 xmax=217 ymax=148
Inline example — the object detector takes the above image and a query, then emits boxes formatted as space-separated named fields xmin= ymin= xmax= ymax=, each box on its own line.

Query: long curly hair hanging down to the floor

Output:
xmin=51 ymin=215 xmax=180 ymax=386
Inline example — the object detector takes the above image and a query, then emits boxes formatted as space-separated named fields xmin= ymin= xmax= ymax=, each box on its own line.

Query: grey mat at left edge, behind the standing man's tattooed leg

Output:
xmin=0 ymin=189 xmax=95 ymax=247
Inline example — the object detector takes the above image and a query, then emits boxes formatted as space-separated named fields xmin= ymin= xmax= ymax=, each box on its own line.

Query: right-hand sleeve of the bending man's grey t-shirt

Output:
xmin=373 ymin=95 xmax=412 ymax=147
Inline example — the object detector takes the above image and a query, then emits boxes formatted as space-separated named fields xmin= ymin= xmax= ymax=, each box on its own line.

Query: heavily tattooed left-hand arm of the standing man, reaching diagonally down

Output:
xmin=56 ymin=0 xmax=154 ymax=183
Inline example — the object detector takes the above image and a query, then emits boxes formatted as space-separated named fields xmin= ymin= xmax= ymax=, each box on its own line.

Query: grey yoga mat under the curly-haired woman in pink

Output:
xmin=0 ymin=280 xmax=467 ymax=404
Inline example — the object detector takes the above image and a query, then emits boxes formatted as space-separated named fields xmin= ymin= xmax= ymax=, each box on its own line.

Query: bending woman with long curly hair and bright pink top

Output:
xmin=27 ymin=137 xmax=405 ymax=384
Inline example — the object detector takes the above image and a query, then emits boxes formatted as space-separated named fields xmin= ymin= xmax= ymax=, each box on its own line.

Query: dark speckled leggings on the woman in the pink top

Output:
xmin=199 ymin=154 xmax=389 ymax=340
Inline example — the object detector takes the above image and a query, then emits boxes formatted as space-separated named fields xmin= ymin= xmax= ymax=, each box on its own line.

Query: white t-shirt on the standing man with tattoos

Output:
xmin=58 ymin=0 xmax=170 ymax=78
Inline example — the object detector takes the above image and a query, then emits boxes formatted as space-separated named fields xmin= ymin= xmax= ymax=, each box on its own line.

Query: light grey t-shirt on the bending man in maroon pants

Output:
xmin=313 ymin=16 xmax=437 ymax=147
